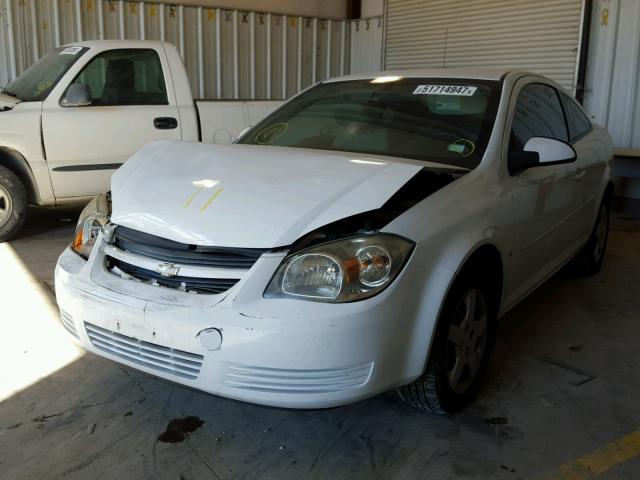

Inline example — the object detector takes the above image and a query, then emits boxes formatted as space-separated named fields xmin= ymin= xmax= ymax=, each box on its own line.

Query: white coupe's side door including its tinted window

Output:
xmin=505 ymin=81 xmax=579 ymax=303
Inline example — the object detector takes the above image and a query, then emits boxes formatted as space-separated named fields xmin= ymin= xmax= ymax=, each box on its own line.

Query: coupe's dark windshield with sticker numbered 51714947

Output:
xmin=238 ymin=77 xmax=500 ymax=169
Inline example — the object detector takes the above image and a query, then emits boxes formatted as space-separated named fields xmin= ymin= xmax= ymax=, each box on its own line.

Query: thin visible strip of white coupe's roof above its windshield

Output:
xmin=325 ymin=68 xmax=535 ymax=83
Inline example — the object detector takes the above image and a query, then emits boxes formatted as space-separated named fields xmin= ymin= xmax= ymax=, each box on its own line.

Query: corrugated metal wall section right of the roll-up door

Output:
xmin=584 ymin=0 xmax=640 ymax=148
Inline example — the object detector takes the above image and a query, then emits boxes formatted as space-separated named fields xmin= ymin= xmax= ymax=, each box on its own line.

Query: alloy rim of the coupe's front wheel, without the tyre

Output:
xmin=446 ymin=289 xmax=487 ymax=394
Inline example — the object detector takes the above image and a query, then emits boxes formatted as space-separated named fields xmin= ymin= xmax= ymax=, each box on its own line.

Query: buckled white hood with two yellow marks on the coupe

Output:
xmin=111 ymin=142 xmax=423 ymax=248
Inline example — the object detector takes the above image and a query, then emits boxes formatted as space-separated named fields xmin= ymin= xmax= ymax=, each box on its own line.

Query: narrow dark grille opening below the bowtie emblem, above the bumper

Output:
xmin=106 ymin=256 xmax=240 ymax=295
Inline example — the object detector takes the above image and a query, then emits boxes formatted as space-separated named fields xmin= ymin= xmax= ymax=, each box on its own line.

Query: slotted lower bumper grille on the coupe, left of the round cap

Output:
xmin=84 ymin=322 xmax=203 ymax=379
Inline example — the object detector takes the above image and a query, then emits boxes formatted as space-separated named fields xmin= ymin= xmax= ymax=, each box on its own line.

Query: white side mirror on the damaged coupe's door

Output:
xmin=509 ymin=137 xmax=577 ymax=174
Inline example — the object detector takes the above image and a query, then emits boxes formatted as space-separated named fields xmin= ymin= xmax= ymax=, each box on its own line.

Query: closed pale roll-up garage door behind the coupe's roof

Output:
xmin=385 ymin=0 xmax=583 ymax=91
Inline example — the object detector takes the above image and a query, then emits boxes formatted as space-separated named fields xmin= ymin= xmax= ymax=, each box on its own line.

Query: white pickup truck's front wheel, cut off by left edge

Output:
xmin=0 ymin=166 xmax=27 ymax=242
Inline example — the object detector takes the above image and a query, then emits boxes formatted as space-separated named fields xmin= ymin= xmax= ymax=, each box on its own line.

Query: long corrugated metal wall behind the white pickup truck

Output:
xmin=0 ymin=0 xmax=368 ymax=98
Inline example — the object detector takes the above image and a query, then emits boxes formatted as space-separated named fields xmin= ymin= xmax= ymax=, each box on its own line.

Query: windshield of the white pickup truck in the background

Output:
xmin=4 ymin=47 xmax=88 ymax=102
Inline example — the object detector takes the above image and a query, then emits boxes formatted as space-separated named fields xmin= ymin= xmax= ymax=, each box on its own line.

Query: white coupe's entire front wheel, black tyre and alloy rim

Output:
xmin=398 ymin=277 xmax=496 ymax=414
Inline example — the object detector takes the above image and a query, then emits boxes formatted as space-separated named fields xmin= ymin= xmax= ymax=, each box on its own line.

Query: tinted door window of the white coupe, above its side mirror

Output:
xmin=509 ymin=83 xmax=569 ymax=151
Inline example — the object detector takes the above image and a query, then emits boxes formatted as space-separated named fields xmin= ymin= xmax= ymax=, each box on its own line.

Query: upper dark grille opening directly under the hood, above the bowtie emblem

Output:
xmin=113 ymin=226 xmax=267 ymax=270
